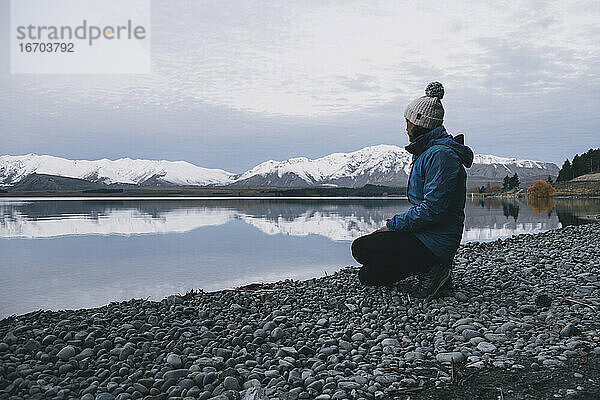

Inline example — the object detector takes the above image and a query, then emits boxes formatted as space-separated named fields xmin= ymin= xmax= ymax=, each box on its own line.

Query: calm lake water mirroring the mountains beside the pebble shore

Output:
xmin=0 ymin=199 xmax=600 ymax=318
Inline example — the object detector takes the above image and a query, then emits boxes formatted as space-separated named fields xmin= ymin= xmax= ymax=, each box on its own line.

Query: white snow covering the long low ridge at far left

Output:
xmin=0 ymin=154 xmax=234 ymax=186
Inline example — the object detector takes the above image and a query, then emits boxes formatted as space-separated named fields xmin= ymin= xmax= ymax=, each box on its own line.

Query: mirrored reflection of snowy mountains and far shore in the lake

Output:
xmin=0 ymin=198 xmax=600 ymax=241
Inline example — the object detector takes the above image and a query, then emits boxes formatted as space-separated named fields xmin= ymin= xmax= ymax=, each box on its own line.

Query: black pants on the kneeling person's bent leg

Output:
xmin=352 ymin=231 xmax=442 ymax=286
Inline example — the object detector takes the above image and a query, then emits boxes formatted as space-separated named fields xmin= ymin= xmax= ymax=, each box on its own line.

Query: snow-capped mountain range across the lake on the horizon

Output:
xmin=0 ymin=145 xmax=559 ymax=188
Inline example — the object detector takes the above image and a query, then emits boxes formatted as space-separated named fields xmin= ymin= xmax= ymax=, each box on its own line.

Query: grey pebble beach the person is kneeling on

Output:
xmin=0 ymin=223 xmax=600 ymax=400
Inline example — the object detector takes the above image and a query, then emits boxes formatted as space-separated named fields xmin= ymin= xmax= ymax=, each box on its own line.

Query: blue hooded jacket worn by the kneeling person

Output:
xmin=386 ymin=126 xmax=473 ymax=265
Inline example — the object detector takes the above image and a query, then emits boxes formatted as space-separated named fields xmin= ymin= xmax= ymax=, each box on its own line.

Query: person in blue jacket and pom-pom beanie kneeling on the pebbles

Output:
xmin=352 ymin=82 xmax=473 ymax=298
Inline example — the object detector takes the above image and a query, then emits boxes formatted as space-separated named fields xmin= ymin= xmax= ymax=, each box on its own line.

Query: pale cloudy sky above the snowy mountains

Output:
xmin=0 ymin=0 xmax=600 ymax=172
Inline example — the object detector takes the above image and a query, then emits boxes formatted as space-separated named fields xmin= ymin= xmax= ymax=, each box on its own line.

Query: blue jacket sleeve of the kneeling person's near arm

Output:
xmin=386 ymin=151 xmax=461 ymax=232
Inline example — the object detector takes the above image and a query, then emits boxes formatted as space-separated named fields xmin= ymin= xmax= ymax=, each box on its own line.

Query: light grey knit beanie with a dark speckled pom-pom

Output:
xmin=404 ymin=82 xmax=444 ymax=129
